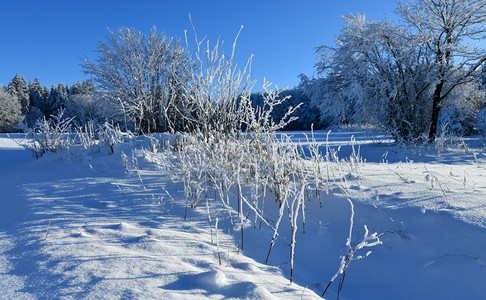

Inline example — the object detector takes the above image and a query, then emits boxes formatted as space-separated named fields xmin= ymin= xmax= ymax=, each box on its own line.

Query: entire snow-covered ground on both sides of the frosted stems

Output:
xmin=0 ymin=132 xmax=486 ymax=299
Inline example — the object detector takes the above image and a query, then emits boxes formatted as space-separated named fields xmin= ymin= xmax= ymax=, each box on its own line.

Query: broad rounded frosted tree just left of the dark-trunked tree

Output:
xmin=312 ymin=15 xmax=434 ymax=140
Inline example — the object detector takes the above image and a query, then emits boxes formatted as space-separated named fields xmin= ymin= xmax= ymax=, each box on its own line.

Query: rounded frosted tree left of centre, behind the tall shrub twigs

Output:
xmin=83 ymin=28 xmax=190 ymax=132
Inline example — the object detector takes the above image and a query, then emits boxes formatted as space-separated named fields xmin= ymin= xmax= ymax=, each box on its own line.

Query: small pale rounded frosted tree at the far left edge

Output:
xmin=0 ymin=86 xmax=23 ymax=132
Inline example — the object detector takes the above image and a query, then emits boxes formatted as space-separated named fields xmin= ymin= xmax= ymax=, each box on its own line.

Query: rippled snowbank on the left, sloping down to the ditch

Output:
xmin=0 ymin=135 xmax=315 ymax=299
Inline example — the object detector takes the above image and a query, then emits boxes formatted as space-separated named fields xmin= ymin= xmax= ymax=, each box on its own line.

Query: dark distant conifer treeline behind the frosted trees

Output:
xmin=0 ymin=74 xmax=322 ymax=132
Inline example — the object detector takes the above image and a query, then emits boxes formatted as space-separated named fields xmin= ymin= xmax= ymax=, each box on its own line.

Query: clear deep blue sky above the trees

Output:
xmin=0 ymin=0 xmax=395 ymax=90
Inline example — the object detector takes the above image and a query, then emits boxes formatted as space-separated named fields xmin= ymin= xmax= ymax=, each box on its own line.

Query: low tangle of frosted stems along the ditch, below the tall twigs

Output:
xmin=150 ymin=83 xmax=378 ymax=281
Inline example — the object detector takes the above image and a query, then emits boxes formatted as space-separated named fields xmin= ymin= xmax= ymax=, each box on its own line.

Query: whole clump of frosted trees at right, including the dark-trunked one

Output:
xmin=303 ymin=0 xmax=486 ymax=141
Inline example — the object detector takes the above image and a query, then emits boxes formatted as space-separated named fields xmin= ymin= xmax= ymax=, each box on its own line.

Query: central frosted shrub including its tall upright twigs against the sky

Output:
xmin=144 ymin=27 xmax=382 ymax=288
